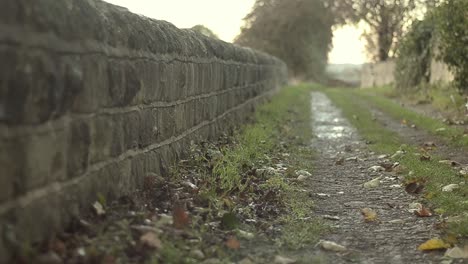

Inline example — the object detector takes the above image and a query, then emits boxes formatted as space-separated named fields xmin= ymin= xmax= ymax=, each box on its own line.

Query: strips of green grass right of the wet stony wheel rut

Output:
xmin=324 ymin=89 xmax=468 ymax=239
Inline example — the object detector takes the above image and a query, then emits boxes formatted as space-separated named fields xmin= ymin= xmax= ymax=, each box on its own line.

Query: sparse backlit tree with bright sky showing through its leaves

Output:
xmin=329 ymin=0 xmax=440 ymax=61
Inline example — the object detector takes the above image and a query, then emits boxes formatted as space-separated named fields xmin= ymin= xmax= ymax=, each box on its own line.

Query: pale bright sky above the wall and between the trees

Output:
xmin=105 ymin=0 xmax=366 ymax=63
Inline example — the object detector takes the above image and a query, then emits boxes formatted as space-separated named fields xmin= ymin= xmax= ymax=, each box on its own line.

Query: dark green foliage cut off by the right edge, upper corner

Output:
xmin=435 ymin=0 xmax=468 ymax=92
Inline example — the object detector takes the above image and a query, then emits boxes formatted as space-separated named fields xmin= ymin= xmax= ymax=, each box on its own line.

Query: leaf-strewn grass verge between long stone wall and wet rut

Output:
xmin=22 ymin=86 xmax=327 ymax=263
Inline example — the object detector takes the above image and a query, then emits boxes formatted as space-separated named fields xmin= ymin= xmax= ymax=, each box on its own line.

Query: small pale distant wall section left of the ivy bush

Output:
xmin=361 ymin=61 xmax=395 ymax=88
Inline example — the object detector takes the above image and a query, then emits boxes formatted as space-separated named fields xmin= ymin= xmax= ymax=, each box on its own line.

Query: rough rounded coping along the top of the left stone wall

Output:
xmin=0 ymin=0 xmax=282 ymax=64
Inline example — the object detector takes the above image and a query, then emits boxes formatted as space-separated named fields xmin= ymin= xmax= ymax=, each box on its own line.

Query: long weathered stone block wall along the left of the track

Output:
xmin=0 ymin=0 xmax=287 ymax=262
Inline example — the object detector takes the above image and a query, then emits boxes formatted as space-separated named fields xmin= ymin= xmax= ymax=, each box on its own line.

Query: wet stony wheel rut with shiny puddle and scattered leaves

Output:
xmin=310 ymin=92 xmax=441 ymax=263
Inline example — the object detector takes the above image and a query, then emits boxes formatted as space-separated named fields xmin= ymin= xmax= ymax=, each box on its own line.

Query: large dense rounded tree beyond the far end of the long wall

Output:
xmin=235 ymin=0 xmax=334 ymax=79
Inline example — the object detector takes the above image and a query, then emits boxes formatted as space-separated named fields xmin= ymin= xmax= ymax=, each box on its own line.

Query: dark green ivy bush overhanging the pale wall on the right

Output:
xmin=395 ymin=15 xmax=435 ymax=90
